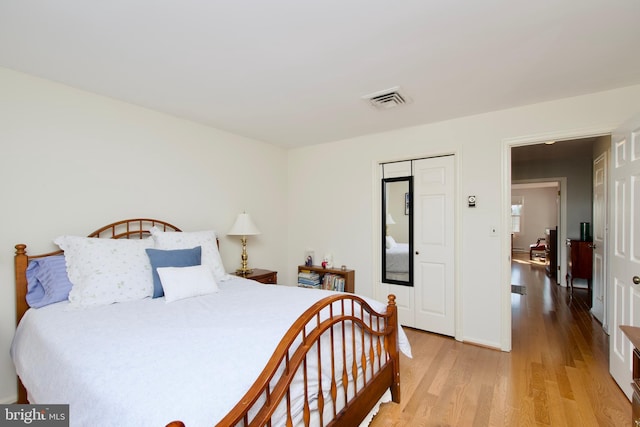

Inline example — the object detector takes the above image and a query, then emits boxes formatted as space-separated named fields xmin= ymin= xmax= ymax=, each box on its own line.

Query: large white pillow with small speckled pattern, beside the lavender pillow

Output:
xmin=54 ymin=236 xmax=153 ymax=307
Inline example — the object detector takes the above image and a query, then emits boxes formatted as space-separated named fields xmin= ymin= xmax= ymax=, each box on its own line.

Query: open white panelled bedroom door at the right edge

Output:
xmin=608 ymin=116 xmax=640 ymax=399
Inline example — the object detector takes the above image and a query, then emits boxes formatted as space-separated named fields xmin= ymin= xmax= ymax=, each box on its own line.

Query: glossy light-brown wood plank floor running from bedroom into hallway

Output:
xmin=371 ymin=254 xmax=631 ymax=427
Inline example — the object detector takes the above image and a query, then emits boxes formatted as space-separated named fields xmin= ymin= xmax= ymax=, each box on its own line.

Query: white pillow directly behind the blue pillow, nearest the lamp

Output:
xmin=150 ymin=227 xmax=230 ymax=282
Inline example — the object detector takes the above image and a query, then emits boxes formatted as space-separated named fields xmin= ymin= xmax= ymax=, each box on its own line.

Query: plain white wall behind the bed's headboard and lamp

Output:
xmin=0 ymin=68 xmax=287 ymax=403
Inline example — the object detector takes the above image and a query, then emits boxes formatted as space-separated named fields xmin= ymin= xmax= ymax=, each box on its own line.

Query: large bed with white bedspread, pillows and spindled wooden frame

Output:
xmin=11 ymin=219 xmax=410 ymax=426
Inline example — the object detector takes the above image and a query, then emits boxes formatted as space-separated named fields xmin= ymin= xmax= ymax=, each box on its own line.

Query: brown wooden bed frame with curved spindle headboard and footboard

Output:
xmin=14 ymin=218 xmax=400 ymax=427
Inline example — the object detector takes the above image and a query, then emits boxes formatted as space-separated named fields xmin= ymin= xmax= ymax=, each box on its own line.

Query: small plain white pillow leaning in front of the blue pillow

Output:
xmin=157 ymin=265 xmax=218 ymax=302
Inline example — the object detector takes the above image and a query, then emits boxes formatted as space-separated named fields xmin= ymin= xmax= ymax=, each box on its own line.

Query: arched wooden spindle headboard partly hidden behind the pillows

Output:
xmin=14 ymin=218 xmax=181 ymax=325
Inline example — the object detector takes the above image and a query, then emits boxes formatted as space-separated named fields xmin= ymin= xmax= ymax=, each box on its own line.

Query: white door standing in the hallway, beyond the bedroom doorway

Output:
xmin=591 ymin=152 xmax=608 ymax=330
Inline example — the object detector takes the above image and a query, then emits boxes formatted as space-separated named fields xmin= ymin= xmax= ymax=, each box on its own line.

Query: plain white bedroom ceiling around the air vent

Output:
xmin=0 ymin=0 xmax=640 ymax=148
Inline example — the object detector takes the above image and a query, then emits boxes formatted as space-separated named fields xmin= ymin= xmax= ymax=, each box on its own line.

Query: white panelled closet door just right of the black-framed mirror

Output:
xmin=412 ymin=156 xmax=455 ymax=336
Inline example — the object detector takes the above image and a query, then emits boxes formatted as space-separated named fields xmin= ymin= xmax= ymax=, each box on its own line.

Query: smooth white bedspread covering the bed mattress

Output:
xmin=11 ymin=278 xmax=411 ymax=427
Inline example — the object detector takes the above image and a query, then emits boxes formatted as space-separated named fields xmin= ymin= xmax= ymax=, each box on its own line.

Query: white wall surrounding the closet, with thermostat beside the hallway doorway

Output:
xmin=287 ymin=86 xmax=640 ymax=348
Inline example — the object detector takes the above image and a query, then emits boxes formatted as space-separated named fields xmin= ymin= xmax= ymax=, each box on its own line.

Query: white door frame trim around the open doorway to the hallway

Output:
xmin=500 ymin=126 xmax=614 ymax=351
